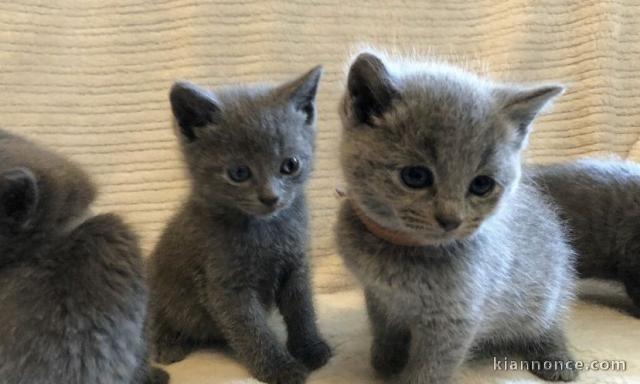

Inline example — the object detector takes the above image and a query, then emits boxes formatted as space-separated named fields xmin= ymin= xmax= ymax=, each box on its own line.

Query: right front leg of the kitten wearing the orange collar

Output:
xmin=395 ymin=317 xmax=475 ymax=384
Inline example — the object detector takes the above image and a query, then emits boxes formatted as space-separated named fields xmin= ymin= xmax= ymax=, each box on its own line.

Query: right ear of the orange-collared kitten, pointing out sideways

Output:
xmin=495 ymin=84 xmax=564 ymax=138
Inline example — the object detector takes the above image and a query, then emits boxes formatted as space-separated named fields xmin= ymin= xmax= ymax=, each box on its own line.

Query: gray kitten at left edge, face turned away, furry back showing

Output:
xmin=0 ymin=131 xmax=168 ymax=384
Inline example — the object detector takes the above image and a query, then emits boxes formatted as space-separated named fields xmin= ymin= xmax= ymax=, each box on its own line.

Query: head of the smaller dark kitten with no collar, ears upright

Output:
xmin=170 ymin=67 xmax=322 ymax=216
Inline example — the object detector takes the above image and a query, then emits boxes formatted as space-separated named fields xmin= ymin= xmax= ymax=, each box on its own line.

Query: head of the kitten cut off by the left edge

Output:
xmin=0 ymin=131 xmax=95 ymax=240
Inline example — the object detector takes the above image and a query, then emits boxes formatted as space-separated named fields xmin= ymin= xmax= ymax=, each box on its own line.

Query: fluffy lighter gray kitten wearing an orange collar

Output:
xmin=336 ymin=53 xmax=576 ymax=384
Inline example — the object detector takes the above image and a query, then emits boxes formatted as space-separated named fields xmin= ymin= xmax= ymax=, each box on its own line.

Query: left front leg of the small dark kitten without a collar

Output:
xmin=208 ymin=286 xmax=308 ymax=384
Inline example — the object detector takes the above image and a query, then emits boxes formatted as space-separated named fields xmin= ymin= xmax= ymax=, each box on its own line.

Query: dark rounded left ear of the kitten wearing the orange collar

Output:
xmin=345 ymin=52 xmax=399 ymax=125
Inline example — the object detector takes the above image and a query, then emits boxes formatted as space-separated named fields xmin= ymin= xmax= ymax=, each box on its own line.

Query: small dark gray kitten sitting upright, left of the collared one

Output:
xmin=151 ymin=67 xmax=331 ymax=384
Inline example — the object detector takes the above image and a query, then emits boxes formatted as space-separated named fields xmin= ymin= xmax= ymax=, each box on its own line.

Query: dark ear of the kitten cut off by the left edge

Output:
xmin=0 ymin=168 xmax=39 ymax=229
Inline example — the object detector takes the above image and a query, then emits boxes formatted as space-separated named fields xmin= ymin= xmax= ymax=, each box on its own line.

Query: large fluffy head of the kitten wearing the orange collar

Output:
xmin=341 ymin=53 xmax=563 ymax=244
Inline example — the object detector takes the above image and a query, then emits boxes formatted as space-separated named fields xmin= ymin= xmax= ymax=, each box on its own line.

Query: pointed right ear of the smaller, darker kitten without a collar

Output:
xmin=275 ymin=65 xmax=322 ymax=125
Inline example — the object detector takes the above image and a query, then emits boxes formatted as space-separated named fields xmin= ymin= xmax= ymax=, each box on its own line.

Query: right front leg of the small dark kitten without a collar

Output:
xmin=277 ymin=266 xmax=331 ymax=370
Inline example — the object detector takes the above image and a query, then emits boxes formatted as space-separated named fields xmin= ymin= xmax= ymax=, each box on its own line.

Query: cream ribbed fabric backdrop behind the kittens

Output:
xmin=0 ymin=0 xmax=640 ymax=383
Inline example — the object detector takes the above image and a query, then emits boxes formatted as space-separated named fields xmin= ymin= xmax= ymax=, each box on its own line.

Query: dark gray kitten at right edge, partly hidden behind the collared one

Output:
xmin=535 ymin=159 xmax=640 ymax=317
